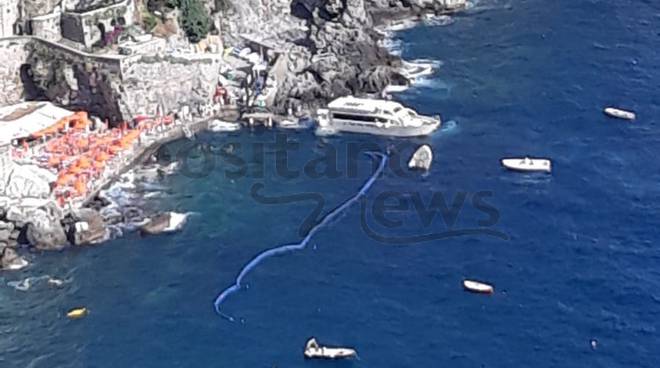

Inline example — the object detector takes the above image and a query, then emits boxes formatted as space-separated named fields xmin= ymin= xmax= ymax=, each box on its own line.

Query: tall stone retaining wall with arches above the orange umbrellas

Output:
xmin=0 ymin=37 xmax=220 ymax=122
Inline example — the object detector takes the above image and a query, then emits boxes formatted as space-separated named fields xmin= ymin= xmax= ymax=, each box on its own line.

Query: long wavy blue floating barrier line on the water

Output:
xmin=213 ymin=152 xmax=388 ymax=321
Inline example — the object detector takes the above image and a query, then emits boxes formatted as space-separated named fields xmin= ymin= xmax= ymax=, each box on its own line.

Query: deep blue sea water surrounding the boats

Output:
xmin=0 ymin=0 xmax=660 ymax=368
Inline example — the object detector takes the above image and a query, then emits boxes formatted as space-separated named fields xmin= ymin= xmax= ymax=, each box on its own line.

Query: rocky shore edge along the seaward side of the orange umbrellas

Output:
xmin=0 ymin=119 xmax=208 ymax=270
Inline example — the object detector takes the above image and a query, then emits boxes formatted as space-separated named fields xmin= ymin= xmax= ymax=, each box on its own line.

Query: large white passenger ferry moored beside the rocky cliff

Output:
xmin=317 ymin=96 xmax=441 ymax=137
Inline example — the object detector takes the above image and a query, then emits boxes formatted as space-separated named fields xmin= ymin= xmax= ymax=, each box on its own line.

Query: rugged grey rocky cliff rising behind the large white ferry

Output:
xmin=217 ymin=0 xmax=465 ymax=111
